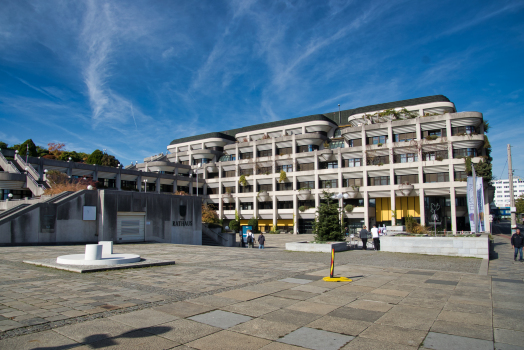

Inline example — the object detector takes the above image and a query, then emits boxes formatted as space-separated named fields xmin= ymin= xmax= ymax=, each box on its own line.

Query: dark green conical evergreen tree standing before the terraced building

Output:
xmin=313 ymin=191 xmax=344 ymax=242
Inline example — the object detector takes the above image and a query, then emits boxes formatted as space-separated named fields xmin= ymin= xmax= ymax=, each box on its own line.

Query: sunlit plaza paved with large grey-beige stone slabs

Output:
xmin=0 ymin=235 xmax=524 ymax=350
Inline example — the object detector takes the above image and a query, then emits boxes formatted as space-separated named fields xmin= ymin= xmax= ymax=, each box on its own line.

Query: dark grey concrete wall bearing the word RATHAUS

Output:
xmin=0 ymin=190 xmax=202 ymax=245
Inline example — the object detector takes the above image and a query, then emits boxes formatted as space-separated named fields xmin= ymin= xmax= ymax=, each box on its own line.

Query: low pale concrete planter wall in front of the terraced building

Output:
xmin=380 ymin=236 xmax=489 ymax=259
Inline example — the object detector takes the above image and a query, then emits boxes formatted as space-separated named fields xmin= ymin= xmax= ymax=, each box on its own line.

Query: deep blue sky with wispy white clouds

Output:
xmin=0 ymin=0 xmax=524 ymax=178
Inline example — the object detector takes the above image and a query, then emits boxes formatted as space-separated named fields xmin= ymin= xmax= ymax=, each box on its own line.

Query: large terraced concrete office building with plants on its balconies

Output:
xmin=150 ymin=95 xmax=489 ymax=233
